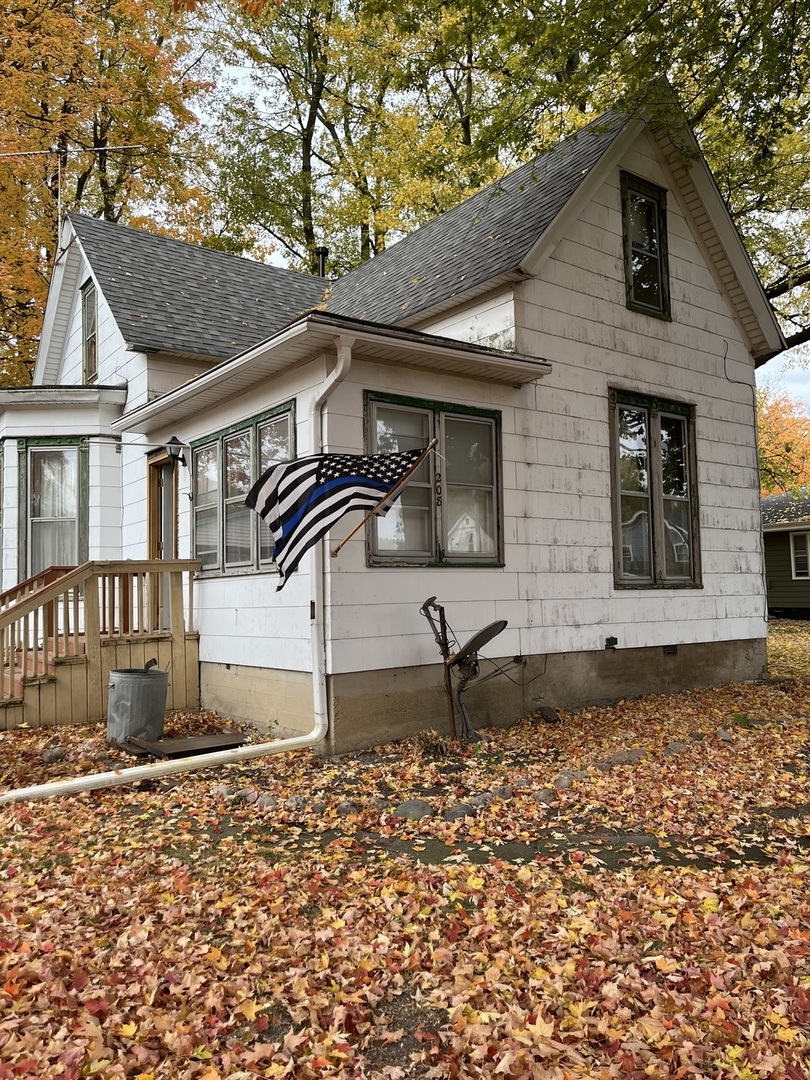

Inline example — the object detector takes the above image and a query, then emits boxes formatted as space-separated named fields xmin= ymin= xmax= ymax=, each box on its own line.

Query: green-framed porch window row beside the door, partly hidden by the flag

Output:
xmin=192 ymin=405 xmax=294 ymax=571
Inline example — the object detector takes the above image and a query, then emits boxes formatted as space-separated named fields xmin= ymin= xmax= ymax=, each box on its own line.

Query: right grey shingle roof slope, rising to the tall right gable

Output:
xmin=326 ymin=112 xmax=625 ymax=324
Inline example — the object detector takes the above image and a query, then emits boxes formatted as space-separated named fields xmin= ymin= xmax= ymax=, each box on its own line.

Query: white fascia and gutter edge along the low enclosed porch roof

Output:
xmin=112 ymin=312 xmax=552 ymax=431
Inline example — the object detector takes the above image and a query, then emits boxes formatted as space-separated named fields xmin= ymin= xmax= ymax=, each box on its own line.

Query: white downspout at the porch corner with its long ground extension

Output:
xmin=0 ymin=337 xmax=353 ymax=806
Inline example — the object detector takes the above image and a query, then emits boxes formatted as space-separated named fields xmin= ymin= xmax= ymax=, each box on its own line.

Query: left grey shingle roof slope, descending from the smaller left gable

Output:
xmin=70 ymin=214 xmax=326 ymax=360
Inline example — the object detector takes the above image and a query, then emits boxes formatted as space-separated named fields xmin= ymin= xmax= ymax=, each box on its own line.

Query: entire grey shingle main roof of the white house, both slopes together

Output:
xmin=70 ymin=113 xmax=624 ymax=360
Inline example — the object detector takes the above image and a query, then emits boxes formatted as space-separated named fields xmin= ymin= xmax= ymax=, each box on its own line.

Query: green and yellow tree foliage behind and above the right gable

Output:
xmin=216 ymin=0 xmax=810 ymax=345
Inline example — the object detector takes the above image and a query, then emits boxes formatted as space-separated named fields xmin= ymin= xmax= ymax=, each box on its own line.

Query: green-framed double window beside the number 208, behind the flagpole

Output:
xmin=366 ymin=394 xmax=501 ymax=566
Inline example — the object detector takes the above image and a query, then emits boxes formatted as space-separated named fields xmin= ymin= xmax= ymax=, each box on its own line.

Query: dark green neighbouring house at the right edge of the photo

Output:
xmin=762 ymin=488 xmax=810 ymax=618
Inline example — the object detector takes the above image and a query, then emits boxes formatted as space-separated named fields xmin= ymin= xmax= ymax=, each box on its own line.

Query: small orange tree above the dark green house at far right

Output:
xmin=757 ymin=386 xmax=810 ymax=495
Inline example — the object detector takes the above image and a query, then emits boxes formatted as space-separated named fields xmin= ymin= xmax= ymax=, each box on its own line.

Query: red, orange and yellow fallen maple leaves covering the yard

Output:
xmin=0 ymin=626 xmax=810 ymax=1080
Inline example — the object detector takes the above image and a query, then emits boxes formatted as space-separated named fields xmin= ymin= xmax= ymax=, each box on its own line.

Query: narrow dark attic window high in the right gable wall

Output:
xmin=621 ymin=173 xmax=670 ymax=319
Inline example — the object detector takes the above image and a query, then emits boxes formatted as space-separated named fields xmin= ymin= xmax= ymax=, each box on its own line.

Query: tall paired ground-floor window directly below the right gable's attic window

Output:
xmin=610 ymin=391 xmax=700 ymax=589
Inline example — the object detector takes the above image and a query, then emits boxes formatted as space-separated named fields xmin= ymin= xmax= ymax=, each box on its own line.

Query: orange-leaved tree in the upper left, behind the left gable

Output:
xmin=0 ymin=0 xmax=209 ymax=386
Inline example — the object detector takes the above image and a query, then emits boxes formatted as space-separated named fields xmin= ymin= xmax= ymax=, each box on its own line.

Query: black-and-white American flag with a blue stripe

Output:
xmin=245 ymin=448 xmax=424 ymax=592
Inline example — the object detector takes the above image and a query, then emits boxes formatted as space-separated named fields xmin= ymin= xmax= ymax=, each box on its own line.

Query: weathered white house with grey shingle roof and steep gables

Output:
xmin=0 ymin=107 xmax=784 ymax=752
